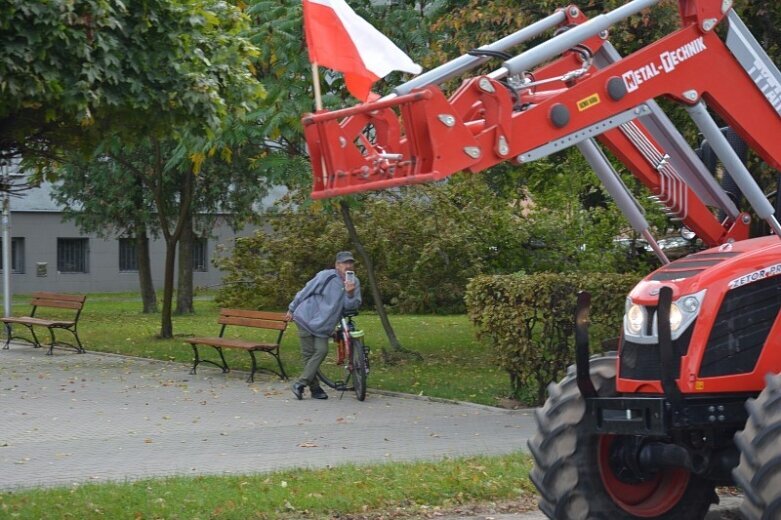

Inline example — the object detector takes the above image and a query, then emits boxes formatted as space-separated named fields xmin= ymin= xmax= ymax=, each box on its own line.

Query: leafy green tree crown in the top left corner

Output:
xmin=0 ymin=0 xmax=262 ymax=159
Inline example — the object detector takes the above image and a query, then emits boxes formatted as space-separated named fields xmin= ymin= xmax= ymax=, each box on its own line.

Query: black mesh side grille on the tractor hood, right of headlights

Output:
xmin=700 ymin=276 xmax=781 ymax=377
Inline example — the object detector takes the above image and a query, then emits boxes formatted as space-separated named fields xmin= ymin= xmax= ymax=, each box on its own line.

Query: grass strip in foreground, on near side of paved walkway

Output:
xmin=0 ymin=454 xmax=534 ymax=520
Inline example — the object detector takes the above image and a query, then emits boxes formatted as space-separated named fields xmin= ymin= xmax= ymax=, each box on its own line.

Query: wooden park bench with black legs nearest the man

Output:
xmin=184 ymin=309 xmax=288 ymax=383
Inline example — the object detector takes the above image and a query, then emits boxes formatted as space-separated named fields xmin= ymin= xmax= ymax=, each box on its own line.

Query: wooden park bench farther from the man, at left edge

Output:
xmin=0 ymin=292 xmax=87 ymax=355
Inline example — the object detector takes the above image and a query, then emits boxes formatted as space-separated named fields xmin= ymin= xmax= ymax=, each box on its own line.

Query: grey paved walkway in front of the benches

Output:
xmin=0 ymin=344 xmax=735 ymax=520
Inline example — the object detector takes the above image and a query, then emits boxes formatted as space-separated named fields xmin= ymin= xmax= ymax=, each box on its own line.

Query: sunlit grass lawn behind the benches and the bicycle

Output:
xmin=7 ymin=294 xmax=509 ymax=405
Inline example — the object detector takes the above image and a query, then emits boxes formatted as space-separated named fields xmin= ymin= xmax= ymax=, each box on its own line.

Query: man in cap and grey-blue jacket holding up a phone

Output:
xmin=287 ymin=251 xmax=361 ymax=400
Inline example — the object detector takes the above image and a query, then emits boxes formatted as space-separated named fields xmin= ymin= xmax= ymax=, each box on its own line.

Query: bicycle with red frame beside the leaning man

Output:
xmin=317 ymin=311 xmax=369 ymax=401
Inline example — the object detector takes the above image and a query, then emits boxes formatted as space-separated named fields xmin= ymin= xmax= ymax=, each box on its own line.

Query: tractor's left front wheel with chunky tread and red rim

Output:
xmin=528 ymin=352 xmax=718 ymax=520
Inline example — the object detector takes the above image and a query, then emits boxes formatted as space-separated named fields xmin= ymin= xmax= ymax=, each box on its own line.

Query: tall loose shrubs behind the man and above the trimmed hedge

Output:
xmin=218 ymin=165 xmax=647 ymax=313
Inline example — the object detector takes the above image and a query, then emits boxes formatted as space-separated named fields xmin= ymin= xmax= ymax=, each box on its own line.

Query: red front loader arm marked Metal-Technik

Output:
xmin=302 ymin=0 xmax=781 ymax=250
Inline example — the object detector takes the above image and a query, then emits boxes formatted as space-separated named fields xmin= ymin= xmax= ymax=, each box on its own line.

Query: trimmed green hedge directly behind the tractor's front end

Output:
xmin=465 ymin=273 xmax=638 ymax=405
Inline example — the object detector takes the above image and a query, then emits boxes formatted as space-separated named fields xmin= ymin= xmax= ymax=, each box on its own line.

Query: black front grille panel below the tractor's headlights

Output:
xmin=619 ymin=320 xmax=697 ymax=381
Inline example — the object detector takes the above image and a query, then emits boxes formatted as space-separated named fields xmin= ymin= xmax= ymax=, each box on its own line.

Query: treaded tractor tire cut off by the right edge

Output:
xmin=732 ymin=374 xmax=781 ymax=520
